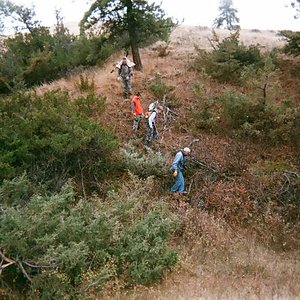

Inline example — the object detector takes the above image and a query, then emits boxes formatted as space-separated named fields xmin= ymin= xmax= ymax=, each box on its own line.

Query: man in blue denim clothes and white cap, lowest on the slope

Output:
xmin=171 ymin=147 xmax=191 ymax=194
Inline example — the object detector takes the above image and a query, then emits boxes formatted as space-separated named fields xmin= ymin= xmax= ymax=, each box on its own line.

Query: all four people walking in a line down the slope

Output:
xmin=116 ymin=57 xmax=191 ymax=194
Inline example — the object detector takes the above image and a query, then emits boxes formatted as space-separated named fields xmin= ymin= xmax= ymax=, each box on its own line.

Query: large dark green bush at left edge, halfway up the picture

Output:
xmin=0 ymin=91 xmax=118 ymax=188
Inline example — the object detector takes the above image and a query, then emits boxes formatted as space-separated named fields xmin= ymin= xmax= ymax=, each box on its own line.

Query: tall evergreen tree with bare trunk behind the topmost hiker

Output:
xmin=81 ymin=0 xmax=174 ymax=70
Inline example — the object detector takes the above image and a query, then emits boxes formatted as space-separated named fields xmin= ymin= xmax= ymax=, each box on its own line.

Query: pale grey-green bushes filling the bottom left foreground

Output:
xmin=0 ymin=176 xmax=176 ymax=299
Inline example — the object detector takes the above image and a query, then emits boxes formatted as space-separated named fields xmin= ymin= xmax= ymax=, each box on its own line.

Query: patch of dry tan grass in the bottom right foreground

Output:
xmin=98 ymin=209 xmax=300 ymax=300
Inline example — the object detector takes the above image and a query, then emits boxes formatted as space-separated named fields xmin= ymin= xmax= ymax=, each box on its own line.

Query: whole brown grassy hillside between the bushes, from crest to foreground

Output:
xmin=37 ymin=26 xmax=300 ymax=299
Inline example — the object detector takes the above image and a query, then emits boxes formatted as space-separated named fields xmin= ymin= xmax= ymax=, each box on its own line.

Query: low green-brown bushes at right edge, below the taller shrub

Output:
xmin=195 ymin=92 xmax=299 ymax=145
